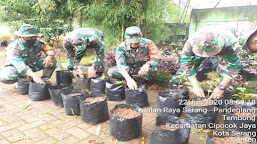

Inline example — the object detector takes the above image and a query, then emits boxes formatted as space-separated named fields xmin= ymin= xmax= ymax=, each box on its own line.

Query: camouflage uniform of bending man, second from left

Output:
xmin=63 ymin=28 xmax=106 ymax=72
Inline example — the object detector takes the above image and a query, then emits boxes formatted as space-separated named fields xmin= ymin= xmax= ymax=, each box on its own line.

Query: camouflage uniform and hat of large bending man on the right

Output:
xmin=172 ymin=24 xmax=241 ymax=83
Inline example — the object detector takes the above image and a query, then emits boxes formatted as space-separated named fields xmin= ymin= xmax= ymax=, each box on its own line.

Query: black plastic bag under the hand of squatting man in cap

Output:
xmin=125 ymin=89 xmax=149 ymax=107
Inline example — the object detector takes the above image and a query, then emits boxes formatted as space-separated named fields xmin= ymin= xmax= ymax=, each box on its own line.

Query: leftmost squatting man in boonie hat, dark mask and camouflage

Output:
xmin=0 ymin=24 xmax=56 ymax=84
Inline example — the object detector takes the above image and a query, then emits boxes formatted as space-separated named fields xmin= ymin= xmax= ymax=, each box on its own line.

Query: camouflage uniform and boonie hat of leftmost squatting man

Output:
xmin=0 ymin=25 xmax=56 ymax=84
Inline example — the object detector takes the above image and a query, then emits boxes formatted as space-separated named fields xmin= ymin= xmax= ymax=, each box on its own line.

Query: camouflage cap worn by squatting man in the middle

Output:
xmin=125 ymin=26 xmax=142 ymax=43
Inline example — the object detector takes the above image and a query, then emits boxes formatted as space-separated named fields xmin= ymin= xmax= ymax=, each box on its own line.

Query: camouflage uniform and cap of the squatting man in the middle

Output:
xmin=108 ymin=27 xmax=161 ymax=80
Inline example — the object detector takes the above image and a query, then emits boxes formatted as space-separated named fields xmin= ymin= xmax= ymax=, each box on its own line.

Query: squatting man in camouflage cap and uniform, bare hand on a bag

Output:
xmin=108 ymin=26 xmax=161 ymax=89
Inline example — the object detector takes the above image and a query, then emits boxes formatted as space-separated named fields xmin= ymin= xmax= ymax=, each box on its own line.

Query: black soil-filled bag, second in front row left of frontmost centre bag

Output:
xmin=61 ymin=89 xmax=88 ymax=115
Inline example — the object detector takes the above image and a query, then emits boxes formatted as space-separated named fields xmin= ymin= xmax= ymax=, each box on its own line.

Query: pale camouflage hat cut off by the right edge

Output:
xmin=239 ymin=26 xmax=257 ymax=50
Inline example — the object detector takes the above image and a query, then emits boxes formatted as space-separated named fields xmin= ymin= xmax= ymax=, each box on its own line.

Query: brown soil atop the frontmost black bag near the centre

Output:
xmin=112 ymin=108 xmax=140 ymax=119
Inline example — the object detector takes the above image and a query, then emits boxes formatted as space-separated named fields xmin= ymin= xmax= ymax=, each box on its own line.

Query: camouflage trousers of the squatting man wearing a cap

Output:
xmin=108 ymin=66 xmax=157 ymax=80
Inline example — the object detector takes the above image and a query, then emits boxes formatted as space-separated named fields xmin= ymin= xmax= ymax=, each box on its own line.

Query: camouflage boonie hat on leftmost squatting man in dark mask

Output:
xmin=14 ymin=24 xmax=42 ymax=37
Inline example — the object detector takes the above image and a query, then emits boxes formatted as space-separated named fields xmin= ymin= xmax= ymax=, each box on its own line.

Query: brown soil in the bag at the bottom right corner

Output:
xmin=212 ymin=136 xmax=250 ymax=144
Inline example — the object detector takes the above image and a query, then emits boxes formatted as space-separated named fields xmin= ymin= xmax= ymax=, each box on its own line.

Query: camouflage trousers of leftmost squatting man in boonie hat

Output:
xmin=0 ymin=58 xmax=56 ymax=84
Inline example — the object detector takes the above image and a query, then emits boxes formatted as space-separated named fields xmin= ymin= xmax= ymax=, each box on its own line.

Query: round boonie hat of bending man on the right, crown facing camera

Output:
xmin=192 ymin=32 xmax=225 ymax=57
